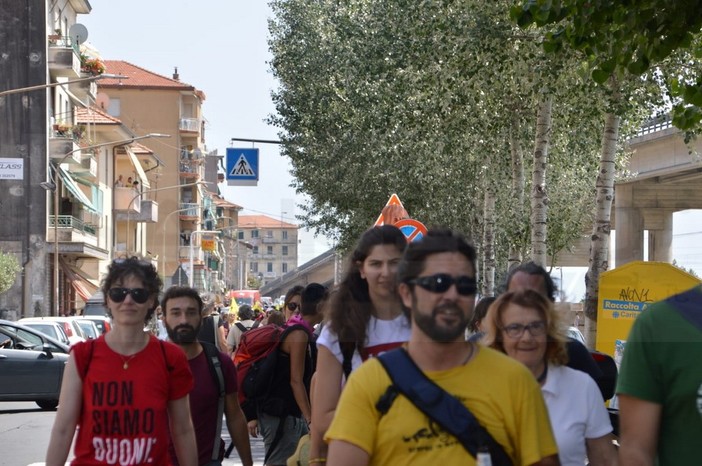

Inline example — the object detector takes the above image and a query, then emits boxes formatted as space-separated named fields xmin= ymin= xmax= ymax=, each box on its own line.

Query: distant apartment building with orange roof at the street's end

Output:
xmin=239 ymin=215 xmax=298 ymax=286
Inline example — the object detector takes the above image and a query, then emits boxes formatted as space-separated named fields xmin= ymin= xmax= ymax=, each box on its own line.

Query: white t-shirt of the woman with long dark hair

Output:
xmin=317 ymin=314 xmax=410 ymax=370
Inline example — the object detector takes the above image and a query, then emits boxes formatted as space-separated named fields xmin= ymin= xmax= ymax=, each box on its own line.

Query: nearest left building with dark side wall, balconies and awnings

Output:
xmin=0 ymin=0 xmax=162 ymax=317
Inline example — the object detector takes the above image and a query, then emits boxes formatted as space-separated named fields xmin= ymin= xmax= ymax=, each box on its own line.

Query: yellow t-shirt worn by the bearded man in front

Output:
xmin=325 ymin=347 xmax=558 ymax=466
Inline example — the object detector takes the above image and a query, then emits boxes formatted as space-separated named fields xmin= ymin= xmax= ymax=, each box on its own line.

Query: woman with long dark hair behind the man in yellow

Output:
xmin=309 ymin=225 xmax=410 ymax=465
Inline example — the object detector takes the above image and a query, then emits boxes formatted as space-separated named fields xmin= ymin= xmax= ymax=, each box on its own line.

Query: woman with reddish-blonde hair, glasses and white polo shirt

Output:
xmin=482 ymin=290 xmax=617 ymax=466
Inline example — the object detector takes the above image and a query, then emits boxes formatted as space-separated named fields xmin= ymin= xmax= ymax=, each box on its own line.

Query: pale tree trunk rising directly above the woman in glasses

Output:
xmin=531 ymin=93 xmax=551 ymax=266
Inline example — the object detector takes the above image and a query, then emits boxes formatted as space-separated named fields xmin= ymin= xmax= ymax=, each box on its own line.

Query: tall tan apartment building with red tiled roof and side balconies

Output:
xmin=98 ymin=60 xmax=236 ymax=291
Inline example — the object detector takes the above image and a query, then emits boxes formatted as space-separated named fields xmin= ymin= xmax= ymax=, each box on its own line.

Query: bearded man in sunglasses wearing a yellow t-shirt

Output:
xmin=324 ymin=230 xmax=559 ymax=466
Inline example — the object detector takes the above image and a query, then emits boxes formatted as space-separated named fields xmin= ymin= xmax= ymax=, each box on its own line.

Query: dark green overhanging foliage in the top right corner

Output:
xmin=511 ymin=0 xmax=702 ymax=130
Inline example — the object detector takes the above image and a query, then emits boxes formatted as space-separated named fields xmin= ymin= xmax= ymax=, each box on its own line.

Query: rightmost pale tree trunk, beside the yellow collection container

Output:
xmin=585 ymin=93 xmax=620 ymax=330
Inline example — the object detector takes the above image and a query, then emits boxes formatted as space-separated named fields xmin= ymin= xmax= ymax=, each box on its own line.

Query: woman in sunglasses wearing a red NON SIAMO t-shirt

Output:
xmin=46 ymin=257 xmax=197 ymax=466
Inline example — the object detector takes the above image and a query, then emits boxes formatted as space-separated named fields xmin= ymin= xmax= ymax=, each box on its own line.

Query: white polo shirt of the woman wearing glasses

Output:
xmin=541 ymin=364 xmax=612 ymax=466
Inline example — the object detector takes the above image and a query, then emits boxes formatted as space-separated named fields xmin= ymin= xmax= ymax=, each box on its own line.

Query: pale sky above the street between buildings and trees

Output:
xmin=78 ymin=0 xmax=329 ymax=264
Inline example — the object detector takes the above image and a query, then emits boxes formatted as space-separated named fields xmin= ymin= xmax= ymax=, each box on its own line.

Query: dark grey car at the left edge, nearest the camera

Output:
xmin=0 ymin=320 xmax=69 ymax=410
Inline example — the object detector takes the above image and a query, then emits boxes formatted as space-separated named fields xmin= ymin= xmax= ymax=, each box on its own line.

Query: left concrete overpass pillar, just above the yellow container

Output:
xmin=614 ymin=184 xmax=643 ymax=267
